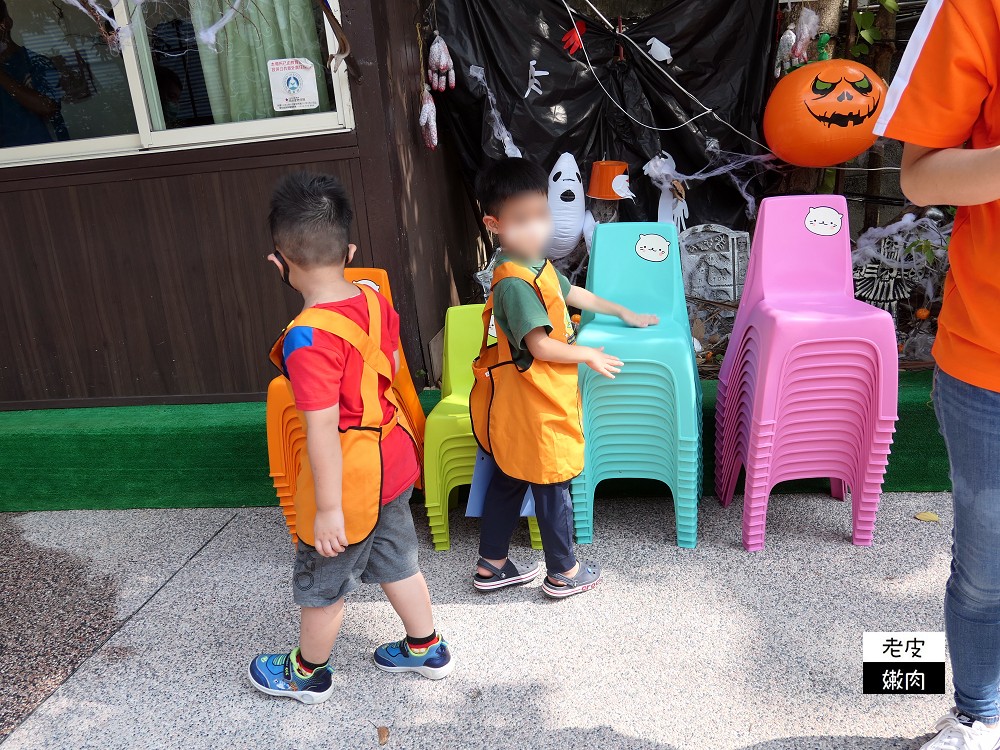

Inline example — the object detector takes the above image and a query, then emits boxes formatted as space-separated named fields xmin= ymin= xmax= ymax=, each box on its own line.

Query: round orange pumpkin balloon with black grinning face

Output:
xmin=764 ymin=60 xmax=886 ymax=167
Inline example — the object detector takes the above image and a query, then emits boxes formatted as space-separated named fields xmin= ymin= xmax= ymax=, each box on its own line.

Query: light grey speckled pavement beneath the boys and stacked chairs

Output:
xmin=0 ymin=494 xmax=950 ymax=750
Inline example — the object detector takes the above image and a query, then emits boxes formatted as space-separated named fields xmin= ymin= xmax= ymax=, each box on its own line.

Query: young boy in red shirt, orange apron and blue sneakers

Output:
xmin=250 ymin=174 xmax=453 ymax=703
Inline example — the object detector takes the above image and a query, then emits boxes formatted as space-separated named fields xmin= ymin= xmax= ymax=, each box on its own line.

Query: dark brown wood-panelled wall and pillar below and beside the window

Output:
xmin=0 ymin=0 xmax=478 ymax=409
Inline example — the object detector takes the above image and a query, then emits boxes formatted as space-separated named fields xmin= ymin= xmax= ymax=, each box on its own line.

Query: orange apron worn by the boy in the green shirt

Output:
xmin=469 ymin=261 xmax=583 ymax=484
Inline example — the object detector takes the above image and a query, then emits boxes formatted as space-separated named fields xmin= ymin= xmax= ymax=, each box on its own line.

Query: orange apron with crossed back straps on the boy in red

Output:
xmin=268 ymin=285 xmax=412 ymax=545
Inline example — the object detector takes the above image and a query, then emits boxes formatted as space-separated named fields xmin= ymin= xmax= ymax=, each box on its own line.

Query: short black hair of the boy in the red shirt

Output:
xmin=268 ymin=172 xmax=354 ymax=268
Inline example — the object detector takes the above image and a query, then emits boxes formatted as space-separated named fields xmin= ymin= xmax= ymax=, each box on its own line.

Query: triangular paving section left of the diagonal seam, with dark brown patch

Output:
xmin=0 ymin=509 xmax=235 ymax=738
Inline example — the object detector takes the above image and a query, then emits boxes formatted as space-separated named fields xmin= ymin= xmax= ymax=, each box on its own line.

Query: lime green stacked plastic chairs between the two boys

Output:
xmin=424 ymin=305 xmax=541 ymax=551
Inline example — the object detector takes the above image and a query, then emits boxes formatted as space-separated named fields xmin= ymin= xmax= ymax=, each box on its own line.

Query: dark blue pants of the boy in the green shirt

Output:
xmin=479 ymin=469 xmax=576 ymax=573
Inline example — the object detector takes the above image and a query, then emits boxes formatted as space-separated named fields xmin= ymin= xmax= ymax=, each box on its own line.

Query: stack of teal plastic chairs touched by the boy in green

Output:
xmin=572 ymin=222 xmax=702 ymax=547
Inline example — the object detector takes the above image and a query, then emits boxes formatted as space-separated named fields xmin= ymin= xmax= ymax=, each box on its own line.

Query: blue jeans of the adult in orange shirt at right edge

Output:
xmin=934 ymin=370 xmax=1000 ymax=724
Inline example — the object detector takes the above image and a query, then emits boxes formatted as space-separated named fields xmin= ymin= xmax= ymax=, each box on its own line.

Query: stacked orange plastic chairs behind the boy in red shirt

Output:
xmin=267 ymin=268 xmax=426 ymax=542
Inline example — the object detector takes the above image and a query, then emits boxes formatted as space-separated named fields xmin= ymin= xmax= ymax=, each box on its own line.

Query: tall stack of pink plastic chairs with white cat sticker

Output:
xmin=715 ymin=195 xmax=898 ymax=551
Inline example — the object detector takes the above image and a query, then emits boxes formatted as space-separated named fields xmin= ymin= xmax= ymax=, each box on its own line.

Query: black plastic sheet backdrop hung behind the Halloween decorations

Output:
xmin=428 ymin=0 xmax=775 ymax=228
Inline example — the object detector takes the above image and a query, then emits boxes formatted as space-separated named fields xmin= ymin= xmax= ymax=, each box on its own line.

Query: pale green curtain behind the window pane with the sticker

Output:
xmin=190 ymin=0 xmax=330 ymax=123
